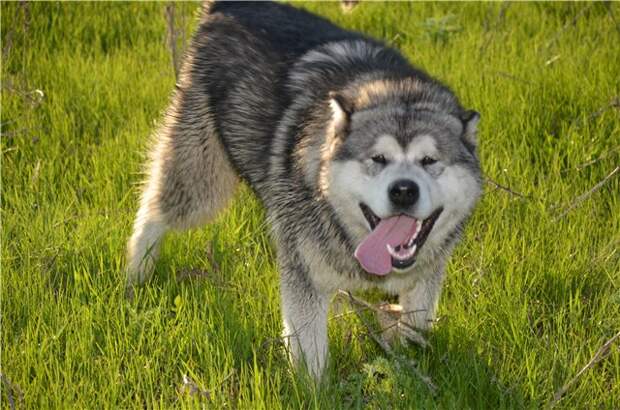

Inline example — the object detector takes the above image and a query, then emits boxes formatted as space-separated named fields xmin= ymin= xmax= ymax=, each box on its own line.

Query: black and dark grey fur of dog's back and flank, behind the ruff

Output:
xmin=192 ymin=2 xmax=376 ymax=186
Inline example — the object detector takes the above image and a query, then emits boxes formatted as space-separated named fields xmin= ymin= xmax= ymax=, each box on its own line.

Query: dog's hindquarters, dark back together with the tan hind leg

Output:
xmin=127 ymin=2 xmax=360 ymax=285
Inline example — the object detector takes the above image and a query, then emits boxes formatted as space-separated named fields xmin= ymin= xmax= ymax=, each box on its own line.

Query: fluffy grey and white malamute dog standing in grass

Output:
xmin=127 ymin=2 xmax=482 ymax=378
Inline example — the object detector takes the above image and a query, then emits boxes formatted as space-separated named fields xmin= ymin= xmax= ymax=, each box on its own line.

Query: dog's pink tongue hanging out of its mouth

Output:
xmin=355 ymin=215 xmax=418 ymax=276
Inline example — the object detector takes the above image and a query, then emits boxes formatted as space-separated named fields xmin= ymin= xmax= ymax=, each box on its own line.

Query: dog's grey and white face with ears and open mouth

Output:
xmin=320 ymin=93 xmax=481 ymax=275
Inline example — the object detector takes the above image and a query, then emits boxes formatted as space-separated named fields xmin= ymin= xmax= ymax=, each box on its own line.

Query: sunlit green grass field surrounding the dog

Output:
xmin=0 ymin=2 xmax=620 ymax=409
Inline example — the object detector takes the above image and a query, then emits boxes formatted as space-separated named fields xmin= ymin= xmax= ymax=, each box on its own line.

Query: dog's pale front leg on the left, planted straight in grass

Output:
xmin=280 ymin=258 xmax=329 ymax=380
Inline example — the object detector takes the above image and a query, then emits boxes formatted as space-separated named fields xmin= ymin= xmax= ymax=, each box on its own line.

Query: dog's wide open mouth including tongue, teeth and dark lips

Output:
xmin=356 ymin=203 xmax=443 ymax=275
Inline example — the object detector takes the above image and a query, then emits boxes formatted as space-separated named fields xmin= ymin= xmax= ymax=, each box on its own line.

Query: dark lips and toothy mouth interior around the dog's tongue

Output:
xmin=359 ymin=203 xmax=443 ymax=270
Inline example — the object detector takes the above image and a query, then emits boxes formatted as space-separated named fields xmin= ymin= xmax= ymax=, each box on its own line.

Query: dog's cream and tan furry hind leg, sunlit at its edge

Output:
xmin=127 ymin=67 xmax=238 ymax=285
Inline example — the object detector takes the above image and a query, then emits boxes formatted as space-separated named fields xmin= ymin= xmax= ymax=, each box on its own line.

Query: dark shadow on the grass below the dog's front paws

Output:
xmin=308 ymin=316 xmax=532 ymax=409
